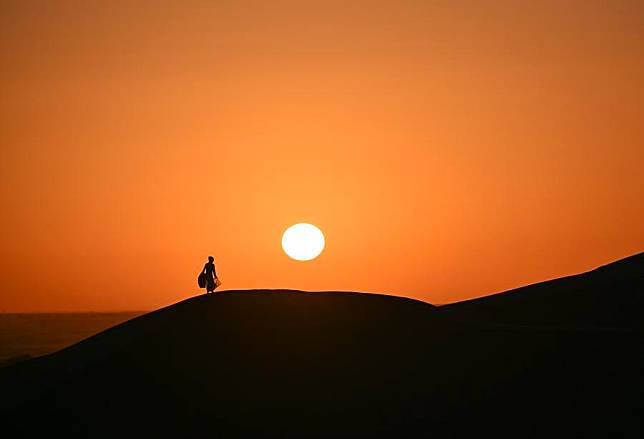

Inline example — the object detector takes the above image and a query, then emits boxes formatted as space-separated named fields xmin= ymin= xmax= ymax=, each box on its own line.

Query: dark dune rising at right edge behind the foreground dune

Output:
xmin=441 ymin=253 xmax=644 ymax=330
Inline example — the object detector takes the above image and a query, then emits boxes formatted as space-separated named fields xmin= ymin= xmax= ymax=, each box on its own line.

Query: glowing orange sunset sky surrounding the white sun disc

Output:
xmin=0 ymin=0 xmax=644 ymax=312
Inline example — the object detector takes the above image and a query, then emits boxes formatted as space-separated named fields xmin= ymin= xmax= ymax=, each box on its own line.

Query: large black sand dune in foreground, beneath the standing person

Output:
xmin=0 ymin=255 xmax=644 ymax=438
